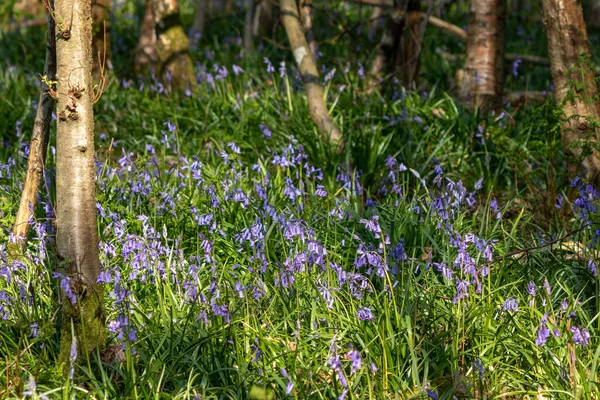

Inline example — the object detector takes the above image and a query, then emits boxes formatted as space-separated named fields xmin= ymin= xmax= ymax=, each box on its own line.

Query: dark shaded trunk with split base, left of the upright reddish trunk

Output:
xmin=368 ymin=0 xmax=423 ymax=91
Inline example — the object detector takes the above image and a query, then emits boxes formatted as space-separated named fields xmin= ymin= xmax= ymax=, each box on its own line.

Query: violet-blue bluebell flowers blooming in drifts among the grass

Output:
xmin=0 ymin=110 xmax=598 ymax=398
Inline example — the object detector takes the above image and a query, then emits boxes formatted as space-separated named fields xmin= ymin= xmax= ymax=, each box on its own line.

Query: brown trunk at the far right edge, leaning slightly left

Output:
xmin=542 ymin=0 xmax=600 ymax=180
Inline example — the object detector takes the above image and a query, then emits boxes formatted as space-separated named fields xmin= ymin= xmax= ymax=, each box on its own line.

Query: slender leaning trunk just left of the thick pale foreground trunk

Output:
xmin=13 ymin=0 xmax=56 ymax=253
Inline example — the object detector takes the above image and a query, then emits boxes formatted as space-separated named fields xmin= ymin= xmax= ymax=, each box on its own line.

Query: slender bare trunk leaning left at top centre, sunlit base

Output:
xmin=280 ymin=0 xmax=343 ymax=151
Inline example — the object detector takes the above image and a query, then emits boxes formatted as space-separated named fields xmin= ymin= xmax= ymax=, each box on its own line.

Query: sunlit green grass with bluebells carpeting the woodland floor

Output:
xmin=0 ymin=2 xmax=600 ymax=399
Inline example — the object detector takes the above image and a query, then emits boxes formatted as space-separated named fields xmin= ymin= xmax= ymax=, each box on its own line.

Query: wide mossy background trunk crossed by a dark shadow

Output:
xmin=136 ymin=0 xmax=196 ymax=91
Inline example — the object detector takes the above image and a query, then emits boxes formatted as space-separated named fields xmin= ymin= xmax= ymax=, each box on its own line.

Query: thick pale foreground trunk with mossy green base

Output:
xmin=55 ymin=0 xmax=106 ymax=365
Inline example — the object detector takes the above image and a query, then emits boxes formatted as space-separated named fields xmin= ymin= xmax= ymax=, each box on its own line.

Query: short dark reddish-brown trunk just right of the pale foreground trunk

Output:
xmin=92 ymin=0 xmax=112 ymax=79
